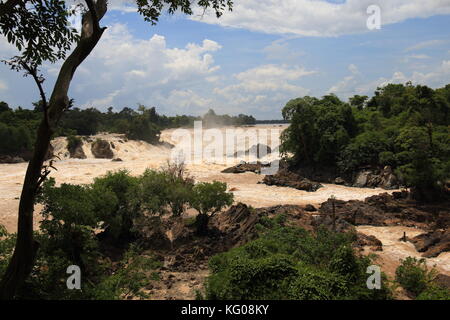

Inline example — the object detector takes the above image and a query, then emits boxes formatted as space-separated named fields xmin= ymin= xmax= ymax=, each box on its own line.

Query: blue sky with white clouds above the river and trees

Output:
xmin=0 ymin=0 xmax=450 ymax=120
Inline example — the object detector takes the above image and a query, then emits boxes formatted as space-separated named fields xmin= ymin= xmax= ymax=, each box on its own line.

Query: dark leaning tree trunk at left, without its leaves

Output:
xmin=0 ymin=0 xmax=107 ymax=299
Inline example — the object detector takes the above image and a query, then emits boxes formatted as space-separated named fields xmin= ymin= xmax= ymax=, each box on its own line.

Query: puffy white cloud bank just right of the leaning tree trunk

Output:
xmin=68 ymin=24 xmax=221 ymax=114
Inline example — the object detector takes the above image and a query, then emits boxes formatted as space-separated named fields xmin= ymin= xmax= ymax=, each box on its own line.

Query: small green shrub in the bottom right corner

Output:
xmin=395 ymin=257 xmax=450 ymax=300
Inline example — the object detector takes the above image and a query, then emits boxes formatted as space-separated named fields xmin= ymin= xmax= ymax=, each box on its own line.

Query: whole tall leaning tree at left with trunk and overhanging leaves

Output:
xmin=0 ymin=0 xmax=233 ymax=299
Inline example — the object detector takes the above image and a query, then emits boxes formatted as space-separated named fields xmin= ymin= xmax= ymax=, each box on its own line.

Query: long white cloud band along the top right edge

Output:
xmin=191 ymin=0 xmax=450 ymax=36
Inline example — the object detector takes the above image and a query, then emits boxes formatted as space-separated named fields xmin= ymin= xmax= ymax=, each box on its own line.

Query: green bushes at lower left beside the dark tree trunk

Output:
xmin=0 ymin=165 xmax=236 ymax=299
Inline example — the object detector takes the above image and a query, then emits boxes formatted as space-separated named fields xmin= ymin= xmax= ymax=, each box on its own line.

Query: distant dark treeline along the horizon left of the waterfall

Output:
xmin=0 ymin=102 xmax=256 ymax=160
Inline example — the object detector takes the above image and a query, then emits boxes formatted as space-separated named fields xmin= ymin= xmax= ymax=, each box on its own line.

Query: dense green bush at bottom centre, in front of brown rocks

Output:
xmin=206 ymin=219 xmax=391 ymax=300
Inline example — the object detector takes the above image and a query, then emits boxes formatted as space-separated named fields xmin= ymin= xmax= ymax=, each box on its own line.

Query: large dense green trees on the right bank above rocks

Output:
xmin=281 ymin=83 xmax=450 ymax=200
